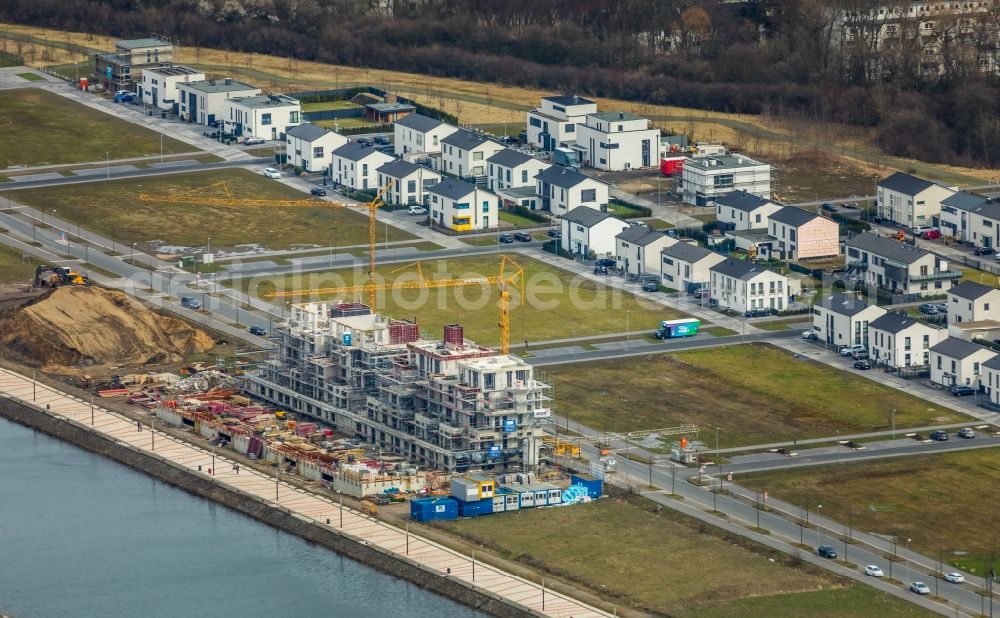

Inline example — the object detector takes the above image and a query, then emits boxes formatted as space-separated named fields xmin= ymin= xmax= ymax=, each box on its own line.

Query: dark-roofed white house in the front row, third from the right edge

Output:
xmin=868 ymin=311 xmax=948 ymax=369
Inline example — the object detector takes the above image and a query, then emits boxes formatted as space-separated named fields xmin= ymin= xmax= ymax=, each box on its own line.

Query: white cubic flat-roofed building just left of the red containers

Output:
xmin=576 ymin=112 xmax=660 ymax=172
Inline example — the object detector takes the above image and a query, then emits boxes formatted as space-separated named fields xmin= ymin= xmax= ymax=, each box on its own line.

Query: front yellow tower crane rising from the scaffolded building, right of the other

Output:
xmin=264 ymin=255 xmax=524 ymax=354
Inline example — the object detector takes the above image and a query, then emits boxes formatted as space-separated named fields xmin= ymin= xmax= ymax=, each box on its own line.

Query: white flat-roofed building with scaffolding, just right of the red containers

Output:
xmin=679 ymin=155 xmax=771 ymax=206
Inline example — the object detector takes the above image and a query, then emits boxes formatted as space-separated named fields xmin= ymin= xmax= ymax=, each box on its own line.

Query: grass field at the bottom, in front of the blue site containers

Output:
xmin=436 ymin=498 xmax=924 ymax=617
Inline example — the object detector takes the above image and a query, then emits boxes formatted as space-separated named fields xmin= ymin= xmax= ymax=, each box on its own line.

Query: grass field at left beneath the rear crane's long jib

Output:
xmin=12 ymin=169 xmax=414 ymax=249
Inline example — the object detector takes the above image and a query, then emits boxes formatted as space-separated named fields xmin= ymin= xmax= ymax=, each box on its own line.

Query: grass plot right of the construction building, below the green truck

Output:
xmin=542 ymin=343 xmax=968 ymax=447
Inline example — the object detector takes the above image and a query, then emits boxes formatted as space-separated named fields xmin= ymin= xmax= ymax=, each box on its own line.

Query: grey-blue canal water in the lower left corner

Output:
xmin=0 ymin=418 xmax=483 ymax=618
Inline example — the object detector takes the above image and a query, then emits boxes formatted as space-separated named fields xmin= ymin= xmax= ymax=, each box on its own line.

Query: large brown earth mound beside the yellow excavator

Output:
xmin=0 ymin=287 xmax=214 ymax=370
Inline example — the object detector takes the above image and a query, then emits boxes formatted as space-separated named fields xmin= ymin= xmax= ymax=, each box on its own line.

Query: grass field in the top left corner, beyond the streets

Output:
xmin=0 ymin=88 xmax=198 ymax=169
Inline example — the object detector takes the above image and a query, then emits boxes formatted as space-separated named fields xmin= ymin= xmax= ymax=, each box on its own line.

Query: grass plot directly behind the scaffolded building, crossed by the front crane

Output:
xmin=246 ymin=251 xmax=684 ymax=348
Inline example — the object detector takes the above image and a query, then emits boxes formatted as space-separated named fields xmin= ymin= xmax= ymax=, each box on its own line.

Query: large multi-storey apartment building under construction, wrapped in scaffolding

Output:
xmin=246 ymin=302 xmax=548 ymax=472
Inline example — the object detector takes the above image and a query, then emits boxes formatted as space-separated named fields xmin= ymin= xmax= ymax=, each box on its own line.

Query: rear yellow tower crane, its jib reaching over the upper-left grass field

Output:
xmin=139 ymin=181 xmax=395 ymax=309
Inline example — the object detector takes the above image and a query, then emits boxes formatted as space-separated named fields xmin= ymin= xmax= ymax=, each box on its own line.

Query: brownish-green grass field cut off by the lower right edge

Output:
xmin=741 ymin=449 xmax=1000 ymax=575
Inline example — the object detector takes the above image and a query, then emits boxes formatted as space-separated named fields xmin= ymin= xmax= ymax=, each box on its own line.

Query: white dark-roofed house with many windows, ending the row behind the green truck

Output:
xmin=709 ymin=258 xmax=788 ymax=313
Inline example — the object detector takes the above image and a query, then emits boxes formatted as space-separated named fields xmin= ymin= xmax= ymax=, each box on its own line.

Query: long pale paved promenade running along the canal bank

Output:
xmin=0 ymin=369 xmax=609 ymax=618
